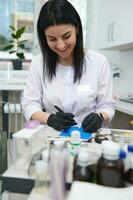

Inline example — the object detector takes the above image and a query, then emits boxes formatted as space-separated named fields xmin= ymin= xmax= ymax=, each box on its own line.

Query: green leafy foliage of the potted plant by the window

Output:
xmin=3 ymin=25 xmax=28 ymax=59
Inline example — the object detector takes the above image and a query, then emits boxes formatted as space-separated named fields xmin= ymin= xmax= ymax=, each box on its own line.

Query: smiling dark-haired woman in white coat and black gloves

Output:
xmin=22 ymin=0 xmax=114 ymax=132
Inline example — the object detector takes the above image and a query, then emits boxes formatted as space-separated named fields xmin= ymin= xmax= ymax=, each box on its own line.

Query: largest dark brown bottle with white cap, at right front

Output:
xmin=97 ymin=141 xmax=125 ymax=187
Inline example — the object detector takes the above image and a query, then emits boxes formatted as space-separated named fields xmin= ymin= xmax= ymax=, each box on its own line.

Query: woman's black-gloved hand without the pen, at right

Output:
xmin=82 ymin=113 xmax=103 ymax=133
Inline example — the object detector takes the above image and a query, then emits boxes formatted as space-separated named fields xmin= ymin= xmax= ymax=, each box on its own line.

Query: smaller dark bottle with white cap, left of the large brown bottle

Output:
xmin=73 ymin=150 xmax=93 ymax=182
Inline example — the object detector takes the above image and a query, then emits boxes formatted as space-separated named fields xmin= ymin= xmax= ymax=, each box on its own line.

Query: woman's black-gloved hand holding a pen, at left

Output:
xmin=47 ymin=111 xmax=77 ymax=131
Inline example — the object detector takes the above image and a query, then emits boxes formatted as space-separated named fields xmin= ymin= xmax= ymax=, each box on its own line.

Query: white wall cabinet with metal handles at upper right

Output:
xmin=97 ymin=0 xmax=133 ymax=50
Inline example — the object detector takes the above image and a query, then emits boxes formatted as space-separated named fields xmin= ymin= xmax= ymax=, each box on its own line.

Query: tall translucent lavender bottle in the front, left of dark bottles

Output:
xmin=49 ymin=140 xmax=67 ymax=200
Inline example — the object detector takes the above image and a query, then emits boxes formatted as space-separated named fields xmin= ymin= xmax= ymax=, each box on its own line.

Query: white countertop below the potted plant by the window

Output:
xmin=0 ymin=70 xmax=29 ymax=91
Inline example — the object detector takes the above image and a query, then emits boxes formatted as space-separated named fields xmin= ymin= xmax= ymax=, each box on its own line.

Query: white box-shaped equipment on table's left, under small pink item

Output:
xmin=13 ymin=125 xmax=46 ymax=171
